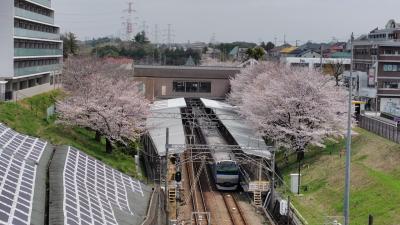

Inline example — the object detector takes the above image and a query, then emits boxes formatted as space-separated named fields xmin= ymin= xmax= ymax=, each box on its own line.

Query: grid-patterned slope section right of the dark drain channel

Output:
xmin=63 ymin=147 xmax=144 ymax=225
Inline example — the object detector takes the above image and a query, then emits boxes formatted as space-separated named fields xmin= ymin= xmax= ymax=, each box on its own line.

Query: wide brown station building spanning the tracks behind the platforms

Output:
xmin=134 ymin=65 xmax=241 ymax=101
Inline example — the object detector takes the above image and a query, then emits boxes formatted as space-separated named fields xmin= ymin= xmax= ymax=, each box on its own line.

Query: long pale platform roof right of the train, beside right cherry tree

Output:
xmin=201 ymin=98 xmax=272 ymax=159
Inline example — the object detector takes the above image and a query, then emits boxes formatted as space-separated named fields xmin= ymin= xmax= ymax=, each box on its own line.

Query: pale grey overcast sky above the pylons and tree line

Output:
xmin=52 ymin=0 xmax=400 ymax=43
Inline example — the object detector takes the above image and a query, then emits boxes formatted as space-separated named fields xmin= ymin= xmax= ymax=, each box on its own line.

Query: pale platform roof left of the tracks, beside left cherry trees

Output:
xmin=146 ymin=98 xmax=186 ymax=156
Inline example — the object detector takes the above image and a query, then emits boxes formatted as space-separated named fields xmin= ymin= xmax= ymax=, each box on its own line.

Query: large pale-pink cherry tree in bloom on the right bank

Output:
xmin=229 ymin=63 xmax=347 ymax=193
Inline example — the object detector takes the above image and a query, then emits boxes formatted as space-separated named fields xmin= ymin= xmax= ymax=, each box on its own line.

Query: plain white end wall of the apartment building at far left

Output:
xmin=0 ymin=0 xmax=14 ymax=78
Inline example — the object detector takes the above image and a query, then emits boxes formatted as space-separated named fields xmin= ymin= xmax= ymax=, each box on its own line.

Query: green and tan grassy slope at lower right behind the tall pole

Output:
xmin=278 ymin=128 xmax=400 ymax=225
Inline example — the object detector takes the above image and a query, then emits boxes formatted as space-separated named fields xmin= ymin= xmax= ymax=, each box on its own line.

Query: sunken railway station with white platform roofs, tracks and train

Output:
xmin=142 ymin=98 xmax=274 ymax=224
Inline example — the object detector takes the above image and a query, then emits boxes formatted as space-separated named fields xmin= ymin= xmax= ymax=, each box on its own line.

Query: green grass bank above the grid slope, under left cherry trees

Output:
xmin=0 ymin=90 xmax=137 ymax=177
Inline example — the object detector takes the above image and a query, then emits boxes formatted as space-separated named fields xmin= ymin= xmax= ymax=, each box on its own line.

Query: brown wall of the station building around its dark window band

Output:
xmin=135 ymin=77 xmax=230 ymax=101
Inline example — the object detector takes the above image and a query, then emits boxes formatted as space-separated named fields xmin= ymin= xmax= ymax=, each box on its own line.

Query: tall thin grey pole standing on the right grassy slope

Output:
xmin=344 ymin=34 xmax=354 ymax=225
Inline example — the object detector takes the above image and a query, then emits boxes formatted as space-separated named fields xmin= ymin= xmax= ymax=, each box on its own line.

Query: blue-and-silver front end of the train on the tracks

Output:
xmin=214 ymin=160 xmax=239 ymax=191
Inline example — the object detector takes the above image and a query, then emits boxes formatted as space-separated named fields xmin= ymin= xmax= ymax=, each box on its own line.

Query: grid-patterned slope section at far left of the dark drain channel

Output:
xmin=0 ymin=124 xmax=47 ymax=225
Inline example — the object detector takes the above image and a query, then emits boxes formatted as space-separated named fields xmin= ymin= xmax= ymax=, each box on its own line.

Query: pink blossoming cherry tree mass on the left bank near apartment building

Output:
xmin=57 ymin=58 xmax=149 ymax=153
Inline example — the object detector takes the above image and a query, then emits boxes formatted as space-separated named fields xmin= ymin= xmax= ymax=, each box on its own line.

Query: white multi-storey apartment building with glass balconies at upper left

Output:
xmin=0 ymin=0 xmax=63 ymax=100
